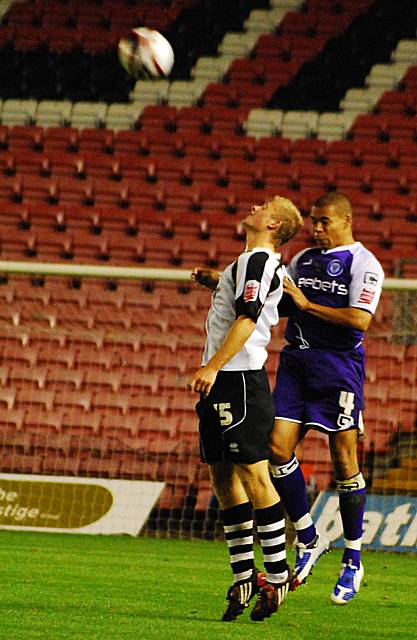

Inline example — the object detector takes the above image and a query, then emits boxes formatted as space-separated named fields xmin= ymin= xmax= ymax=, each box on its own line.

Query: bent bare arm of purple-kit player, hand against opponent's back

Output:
xmin=284 ymin=278 xmax=372 ymax=331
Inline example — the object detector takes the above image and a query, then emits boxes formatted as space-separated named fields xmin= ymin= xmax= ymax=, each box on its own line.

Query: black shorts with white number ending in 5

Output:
xmin=196 ymin=369 xmax=275 ymax=464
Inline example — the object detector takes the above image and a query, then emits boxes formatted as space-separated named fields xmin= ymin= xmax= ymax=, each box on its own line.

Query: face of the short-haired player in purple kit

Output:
xmin=311 ymin=205 xmax=351 ymax=249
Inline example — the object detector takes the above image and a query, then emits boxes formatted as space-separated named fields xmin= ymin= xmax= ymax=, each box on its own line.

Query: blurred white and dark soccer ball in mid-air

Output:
xmin=118 ymin=27 xmax=174 ymax=78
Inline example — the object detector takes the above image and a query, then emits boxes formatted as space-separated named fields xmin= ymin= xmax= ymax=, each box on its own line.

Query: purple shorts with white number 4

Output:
xmin=274 ymin=347 xmax=365 ymax=433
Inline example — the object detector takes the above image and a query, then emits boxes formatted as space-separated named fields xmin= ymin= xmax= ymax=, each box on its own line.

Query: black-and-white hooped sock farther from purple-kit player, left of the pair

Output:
xmin=221 ymin=502 xmax=255 ymax=583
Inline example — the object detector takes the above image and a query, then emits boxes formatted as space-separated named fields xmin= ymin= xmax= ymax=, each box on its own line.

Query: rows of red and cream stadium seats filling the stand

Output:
xmin=0 ymin=0 xmax=417 ymax=508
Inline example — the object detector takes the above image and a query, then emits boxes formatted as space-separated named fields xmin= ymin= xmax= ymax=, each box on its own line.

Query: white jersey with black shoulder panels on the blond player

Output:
xmin=202 ymin=247 xmax=286 ymax=371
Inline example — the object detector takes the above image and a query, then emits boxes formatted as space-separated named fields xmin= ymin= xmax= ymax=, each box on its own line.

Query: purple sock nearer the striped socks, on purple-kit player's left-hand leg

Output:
xmin=269 ymin=454 xmax=317 ymax=544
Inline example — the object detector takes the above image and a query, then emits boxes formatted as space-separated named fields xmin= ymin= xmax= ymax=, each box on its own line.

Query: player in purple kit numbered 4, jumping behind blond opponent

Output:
xmin=270 ymin=192 xmax=384 ymax=605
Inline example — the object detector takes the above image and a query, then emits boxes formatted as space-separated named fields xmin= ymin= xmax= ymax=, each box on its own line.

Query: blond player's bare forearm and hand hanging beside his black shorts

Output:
xmin=187 ymin=316 xmax=256 ymax=395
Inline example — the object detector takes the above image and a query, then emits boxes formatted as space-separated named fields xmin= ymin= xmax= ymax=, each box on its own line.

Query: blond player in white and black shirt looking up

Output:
xmin=188 ymin=196 xmax=303 ymax=622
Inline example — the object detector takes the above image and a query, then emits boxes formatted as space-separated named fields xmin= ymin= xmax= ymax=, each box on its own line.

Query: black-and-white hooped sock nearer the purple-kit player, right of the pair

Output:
xmin=255 ymin=502 xmax=288 ymax=584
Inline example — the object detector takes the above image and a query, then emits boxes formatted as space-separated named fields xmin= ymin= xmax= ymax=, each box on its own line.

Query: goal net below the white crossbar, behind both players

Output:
xmin=0 ymin=263 xmax=417 ymax=538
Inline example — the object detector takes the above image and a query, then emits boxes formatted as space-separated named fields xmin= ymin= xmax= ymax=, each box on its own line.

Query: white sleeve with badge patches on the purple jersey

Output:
xmin=349 ymin=247 xmax=385 ymax=315
